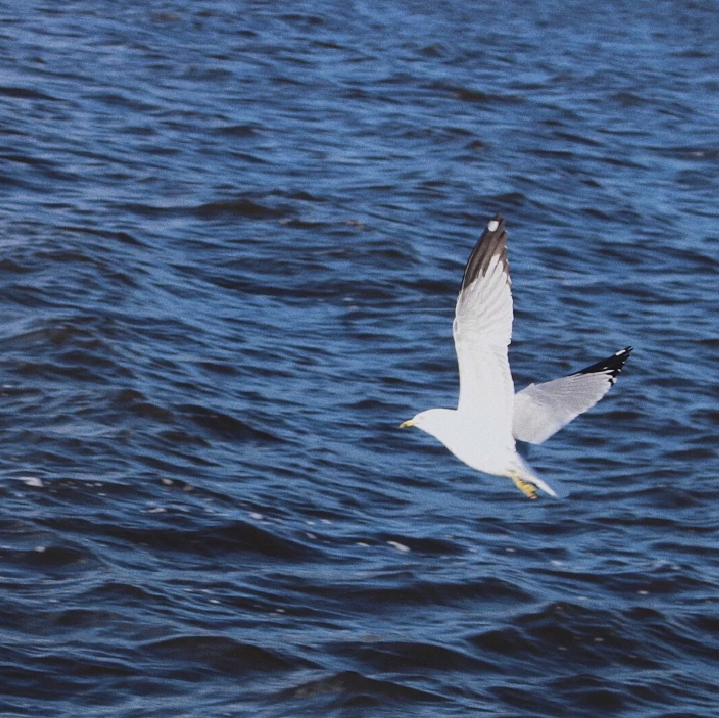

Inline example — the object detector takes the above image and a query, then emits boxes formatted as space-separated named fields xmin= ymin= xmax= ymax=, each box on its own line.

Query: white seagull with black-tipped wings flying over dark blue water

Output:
xmin=400 ymin=214 xmax=632 ymax=499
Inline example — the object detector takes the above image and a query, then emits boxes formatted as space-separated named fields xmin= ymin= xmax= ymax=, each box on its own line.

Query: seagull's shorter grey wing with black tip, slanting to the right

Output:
xmin=513 ymin=347 xmax=632 ymax=444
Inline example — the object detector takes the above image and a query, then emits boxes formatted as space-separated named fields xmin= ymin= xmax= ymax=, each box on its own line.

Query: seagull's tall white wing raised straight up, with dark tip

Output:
xmin=454 ymin=214 xmax=514 ymax=445
